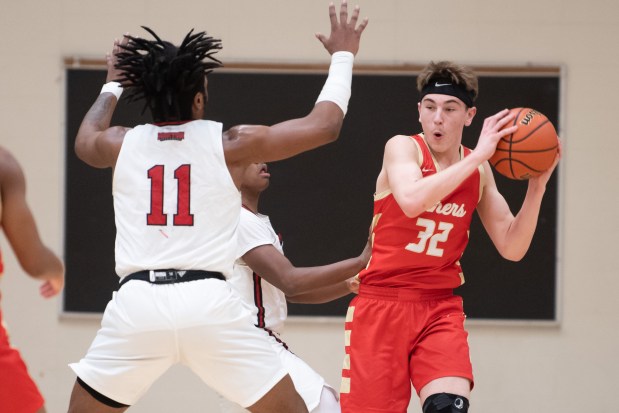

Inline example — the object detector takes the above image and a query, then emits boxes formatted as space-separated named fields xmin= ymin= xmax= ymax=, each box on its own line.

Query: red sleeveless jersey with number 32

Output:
xmin=359 ymin=134 xmax=483 ymax=289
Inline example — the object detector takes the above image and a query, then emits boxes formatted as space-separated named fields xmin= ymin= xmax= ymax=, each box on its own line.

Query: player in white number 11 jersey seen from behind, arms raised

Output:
xmin=69 ymin=2 xmax=367 ymax=413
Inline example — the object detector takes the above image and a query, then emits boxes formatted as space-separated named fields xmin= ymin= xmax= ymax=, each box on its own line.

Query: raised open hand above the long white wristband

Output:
xmin=316 ymin=0 xmax=368 ymax=55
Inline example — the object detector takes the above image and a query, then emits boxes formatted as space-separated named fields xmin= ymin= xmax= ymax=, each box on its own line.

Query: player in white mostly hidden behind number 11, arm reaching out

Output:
xmin=220 ymin=163 xmax=371 ymax=413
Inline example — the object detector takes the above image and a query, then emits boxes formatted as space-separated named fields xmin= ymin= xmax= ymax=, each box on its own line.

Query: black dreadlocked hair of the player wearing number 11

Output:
xmin=116 ymin=26 xmax=222 ymax=122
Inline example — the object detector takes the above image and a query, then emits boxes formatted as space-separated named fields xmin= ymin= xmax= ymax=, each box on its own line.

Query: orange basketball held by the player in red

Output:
xmin=489 ymin=108 xmax=559 ymax=179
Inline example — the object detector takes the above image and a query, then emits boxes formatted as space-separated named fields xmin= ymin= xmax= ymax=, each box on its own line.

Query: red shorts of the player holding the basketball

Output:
xmin=340 ymin=284 xmax=473 ymax=413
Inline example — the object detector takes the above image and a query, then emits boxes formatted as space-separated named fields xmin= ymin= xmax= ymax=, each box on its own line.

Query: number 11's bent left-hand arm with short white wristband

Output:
xmin=75 ymin=37 xmax=128 ymax=168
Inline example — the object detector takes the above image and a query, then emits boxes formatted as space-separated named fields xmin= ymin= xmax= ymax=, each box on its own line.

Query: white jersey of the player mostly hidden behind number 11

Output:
xmin=228 ymin=208 xmax=288 ymax=335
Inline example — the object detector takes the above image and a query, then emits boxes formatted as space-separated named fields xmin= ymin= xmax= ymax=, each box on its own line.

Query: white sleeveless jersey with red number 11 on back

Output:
xmin=112 ymin=120 xmax=241 ymax=278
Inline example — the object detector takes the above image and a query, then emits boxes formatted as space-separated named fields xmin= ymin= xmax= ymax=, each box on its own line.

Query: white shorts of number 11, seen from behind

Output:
xmin=70 ymin=279 xmax=288 ymax=407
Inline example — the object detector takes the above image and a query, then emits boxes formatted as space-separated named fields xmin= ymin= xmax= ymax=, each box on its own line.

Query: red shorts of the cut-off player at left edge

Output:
xmin=0 ymin=311 xmax=44 ymax=413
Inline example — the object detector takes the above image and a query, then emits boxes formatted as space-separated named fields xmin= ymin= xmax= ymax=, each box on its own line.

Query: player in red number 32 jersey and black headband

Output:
xmin=341 ymin=62 xmax=560 ymax=413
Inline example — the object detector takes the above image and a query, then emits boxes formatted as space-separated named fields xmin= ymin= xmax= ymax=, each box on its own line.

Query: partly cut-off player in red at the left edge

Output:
xmin=0 ymin=147 xmax=64 ymax=413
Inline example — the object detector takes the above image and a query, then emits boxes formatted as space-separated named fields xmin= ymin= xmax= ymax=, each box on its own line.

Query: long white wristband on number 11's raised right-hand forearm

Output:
xmin=316 ymin=52 xmax=355 ymax=115
